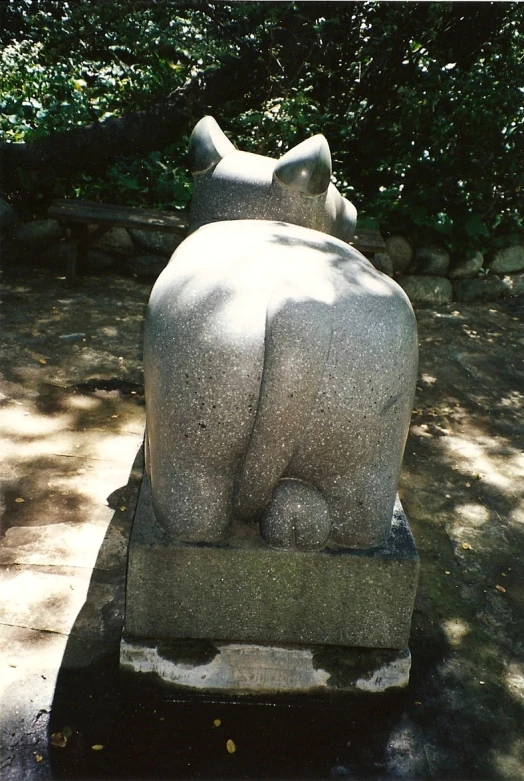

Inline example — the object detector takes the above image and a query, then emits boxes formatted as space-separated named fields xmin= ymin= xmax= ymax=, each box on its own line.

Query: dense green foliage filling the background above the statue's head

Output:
xmin=0 ymin=0 xmax=524 ymax=251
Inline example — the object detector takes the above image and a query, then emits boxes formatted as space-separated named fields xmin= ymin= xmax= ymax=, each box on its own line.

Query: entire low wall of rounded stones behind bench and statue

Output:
xmin=0 ymin=199 xmax=524 ymax=306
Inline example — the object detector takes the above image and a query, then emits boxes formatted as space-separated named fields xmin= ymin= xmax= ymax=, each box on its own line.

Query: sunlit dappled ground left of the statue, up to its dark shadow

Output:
xmin=0 ymin=268 xmax=149 ymax=779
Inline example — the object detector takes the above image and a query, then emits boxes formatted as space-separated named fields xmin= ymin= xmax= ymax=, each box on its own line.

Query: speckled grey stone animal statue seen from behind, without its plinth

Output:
xmin=144 ymin=117 xmax=417 ymax=550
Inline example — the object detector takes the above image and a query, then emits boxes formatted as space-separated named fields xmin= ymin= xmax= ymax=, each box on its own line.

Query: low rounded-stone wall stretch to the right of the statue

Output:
xmin=370 ymin=236 xmax=524 ymax=305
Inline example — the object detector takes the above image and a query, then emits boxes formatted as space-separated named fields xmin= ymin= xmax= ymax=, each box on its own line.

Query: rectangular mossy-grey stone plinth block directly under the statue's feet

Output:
xmin=125 ymin=476 xmax=419 ymax=649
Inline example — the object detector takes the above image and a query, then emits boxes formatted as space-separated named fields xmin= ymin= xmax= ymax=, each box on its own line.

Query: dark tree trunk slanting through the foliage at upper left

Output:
xmin=0 ymin=60 xmax=267 ymax=201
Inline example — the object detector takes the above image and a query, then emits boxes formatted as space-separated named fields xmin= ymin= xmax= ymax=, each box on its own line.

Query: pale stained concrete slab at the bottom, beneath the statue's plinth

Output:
xmin=120 ymin=636 xmax=411 ymax=695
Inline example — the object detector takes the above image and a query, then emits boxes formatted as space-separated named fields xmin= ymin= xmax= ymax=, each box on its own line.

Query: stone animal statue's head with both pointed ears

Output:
xmin=189 ymin=117 xmax=357 ymax=241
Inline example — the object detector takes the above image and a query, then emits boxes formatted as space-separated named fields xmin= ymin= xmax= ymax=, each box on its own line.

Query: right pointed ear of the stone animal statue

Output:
xmin=275 ymin=134 xmax=331 ymax=195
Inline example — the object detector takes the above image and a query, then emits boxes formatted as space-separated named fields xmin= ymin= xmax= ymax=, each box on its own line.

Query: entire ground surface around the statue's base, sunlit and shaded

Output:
xmin=0 ymin=267 xmax=524 ymax=781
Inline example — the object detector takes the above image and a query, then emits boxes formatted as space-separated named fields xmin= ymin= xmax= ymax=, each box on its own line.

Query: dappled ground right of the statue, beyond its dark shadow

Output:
xmin=401 ymin=300 xmax=524 ymax=779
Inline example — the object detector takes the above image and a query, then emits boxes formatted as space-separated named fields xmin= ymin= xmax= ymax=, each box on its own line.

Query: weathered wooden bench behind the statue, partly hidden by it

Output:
xmin=48 ymin=199 xmax=386 ymax=285
